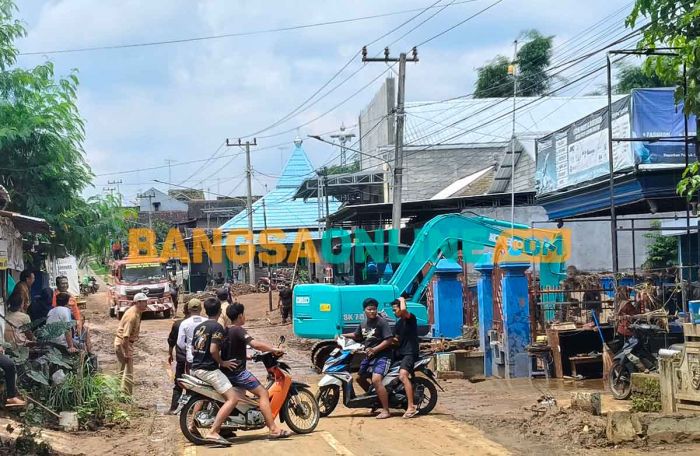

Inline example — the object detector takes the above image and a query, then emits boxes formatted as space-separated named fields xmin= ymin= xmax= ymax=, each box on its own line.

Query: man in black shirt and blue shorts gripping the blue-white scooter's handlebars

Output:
xmin=343 ymin=298 xmax=394 ymax=420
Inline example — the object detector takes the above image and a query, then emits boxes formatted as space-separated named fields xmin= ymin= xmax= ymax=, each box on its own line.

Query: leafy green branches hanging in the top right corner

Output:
xmin=627 ymin=0 xmax=700 ymax=199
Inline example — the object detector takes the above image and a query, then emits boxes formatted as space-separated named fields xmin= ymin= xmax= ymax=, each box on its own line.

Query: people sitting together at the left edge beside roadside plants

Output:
xmin=0 ymin=270 xmax=92 ymax=407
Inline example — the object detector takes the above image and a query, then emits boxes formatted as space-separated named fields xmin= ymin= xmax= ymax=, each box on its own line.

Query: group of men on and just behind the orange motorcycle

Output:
xmin=165 ymin=288 xmax=289 ymax=445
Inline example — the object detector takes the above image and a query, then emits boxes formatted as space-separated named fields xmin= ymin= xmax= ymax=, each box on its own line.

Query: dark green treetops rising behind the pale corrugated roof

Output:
xmin=474 ymin=30 xmax=554 ymax=98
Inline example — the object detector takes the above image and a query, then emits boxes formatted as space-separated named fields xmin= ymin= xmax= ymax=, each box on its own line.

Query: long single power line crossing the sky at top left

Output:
xmin=19 ymin=0 xmax=477 ymax=55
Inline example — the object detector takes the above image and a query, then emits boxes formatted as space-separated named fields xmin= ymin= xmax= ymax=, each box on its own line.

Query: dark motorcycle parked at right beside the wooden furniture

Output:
xmin=608 ymin=323 xmax=683 ymax=400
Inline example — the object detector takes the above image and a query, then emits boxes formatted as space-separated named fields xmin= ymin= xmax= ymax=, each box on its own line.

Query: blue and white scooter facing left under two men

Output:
xmin=316 ymin=336 xmax=444 ymax=417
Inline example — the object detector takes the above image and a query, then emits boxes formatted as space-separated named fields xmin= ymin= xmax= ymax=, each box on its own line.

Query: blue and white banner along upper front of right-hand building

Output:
xmin=535 ymin=88 xmax=695 ymax=195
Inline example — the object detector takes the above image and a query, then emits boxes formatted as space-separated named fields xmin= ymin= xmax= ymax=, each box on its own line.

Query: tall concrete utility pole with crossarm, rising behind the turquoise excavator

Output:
xmin=362 ymin=46 xmax=418 ymax=233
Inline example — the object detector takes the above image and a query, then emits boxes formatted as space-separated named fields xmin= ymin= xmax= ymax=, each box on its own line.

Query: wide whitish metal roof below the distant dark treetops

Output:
xmin=404 ymin=95 xmax=621 ymax=146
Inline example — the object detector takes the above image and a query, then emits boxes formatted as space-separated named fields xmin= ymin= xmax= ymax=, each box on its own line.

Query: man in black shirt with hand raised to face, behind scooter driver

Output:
xmin=391 ymin=298 xmax=419 ymax=418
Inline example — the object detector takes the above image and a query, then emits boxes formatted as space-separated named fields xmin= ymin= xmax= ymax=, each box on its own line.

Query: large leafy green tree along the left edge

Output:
xmin=0 ymin=0 xmax=124 ymax=255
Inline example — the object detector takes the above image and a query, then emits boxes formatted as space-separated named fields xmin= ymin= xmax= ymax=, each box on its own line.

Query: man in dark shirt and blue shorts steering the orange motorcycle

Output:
xmin=222 ymin=302 xmax=290 ymax=439
